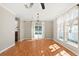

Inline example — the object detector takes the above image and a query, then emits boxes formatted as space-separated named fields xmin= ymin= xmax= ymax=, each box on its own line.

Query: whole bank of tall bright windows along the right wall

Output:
xmin=57 ymin=7 xmax=79 ymax=48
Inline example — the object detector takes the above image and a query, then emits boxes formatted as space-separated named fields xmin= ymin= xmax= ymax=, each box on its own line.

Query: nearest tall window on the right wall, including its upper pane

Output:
xmin=65 ymin=8 xmax=78 ymax=48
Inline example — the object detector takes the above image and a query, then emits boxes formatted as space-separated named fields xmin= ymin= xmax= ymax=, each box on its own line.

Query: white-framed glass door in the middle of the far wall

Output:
xmin=32 ymin=21 xmax=44 ymax=39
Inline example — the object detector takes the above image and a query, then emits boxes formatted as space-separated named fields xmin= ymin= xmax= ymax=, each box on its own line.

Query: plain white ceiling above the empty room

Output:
xmin=2 ymin=3 xmax=75 ymax=21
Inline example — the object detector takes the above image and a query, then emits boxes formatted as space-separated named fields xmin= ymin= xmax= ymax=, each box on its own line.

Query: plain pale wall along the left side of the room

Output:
xmin=0 ymin=6 xmax=15 ymax=52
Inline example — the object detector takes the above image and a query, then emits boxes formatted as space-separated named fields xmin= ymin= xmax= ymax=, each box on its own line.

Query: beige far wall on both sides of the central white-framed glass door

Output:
xmin=20 ymin=21 xmax=53 ymax=39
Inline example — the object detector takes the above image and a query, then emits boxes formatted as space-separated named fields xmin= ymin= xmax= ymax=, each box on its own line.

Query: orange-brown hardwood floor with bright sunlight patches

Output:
xmin=0 ymin=39 xmax=75 ymax=56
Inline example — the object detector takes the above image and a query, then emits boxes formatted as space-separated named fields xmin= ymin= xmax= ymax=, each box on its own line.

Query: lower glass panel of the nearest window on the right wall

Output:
xmin=67 ymin=20 xmax=78 ymax=47
